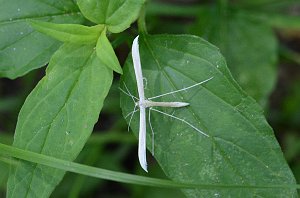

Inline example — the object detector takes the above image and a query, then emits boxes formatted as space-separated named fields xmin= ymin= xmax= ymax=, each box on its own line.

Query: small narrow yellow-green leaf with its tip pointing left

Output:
xmin=30 ymin=21 xmax=104 ymax=44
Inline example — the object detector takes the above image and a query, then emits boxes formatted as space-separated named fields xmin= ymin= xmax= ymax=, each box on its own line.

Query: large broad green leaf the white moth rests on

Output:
xmin=121 ymin=35 xmax=297 ymax=197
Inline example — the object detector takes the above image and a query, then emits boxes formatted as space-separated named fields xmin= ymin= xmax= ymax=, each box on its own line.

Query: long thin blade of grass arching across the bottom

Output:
xmin=0 ymin=144 xmax=300 ymax=189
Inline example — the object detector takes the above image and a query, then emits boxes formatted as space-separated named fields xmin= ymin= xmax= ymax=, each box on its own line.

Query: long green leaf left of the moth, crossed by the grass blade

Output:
xmin=7 ymin=44 xmax=112 ymax=197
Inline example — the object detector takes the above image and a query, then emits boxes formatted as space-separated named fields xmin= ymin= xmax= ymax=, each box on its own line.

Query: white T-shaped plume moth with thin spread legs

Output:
xmin=121 ymin=36 xmax=213 ymax=172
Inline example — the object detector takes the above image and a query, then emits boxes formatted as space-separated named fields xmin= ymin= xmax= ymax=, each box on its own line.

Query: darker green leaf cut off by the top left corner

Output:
xmin=0 ymin=0 xmax=84 ymax=78
